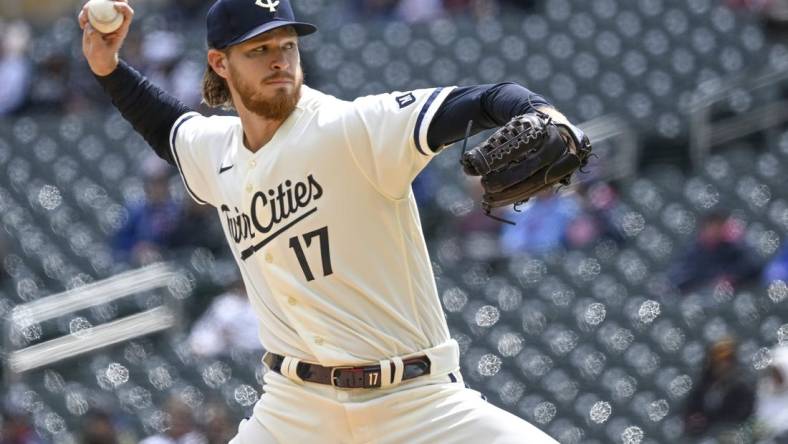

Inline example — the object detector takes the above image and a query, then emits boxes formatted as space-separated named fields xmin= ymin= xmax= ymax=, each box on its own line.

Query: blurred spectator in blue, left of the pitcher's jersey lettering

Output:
xmin=112 ymin=158 xmax=181 ymax=264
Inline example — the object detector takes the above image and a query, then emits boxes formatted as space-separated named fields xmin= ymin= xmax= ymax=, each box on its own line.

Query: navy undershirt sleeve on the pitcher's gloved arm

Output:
xmin=427 ymin=83 xmax=552 ymax=151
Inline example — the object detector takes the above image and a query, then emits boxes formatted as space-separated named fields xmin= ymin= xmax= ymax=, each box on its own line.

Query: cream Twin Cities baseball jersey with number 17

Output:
xmin=170 ymin=86 xmax=453 ymax=366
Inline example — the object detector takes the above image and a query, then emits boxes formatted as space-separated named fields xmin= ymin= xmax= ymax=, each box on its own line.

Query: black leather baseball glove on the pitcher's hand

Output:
xmin=460 ymin=112 xmax=591 ymax=214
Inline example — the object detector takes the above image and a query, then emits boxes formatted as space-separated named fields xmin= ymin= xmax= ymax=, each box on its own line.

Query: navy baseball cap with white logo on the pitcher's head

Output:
xmin=207 ymin=0 xmax=317 ymax=49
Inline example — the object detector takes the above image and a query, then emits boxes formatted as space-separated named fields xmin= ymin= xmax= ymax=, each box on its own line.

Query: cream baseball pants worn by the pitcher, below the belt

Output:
xmin=230 ymin=342 xmax=556 ymax=444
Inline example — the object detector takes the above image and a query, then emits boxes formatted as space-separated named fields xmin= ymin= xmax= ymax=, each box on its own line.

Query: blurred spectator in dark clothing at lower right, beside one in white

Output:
xmin=684 ymin=338 xmax=755 ymax=437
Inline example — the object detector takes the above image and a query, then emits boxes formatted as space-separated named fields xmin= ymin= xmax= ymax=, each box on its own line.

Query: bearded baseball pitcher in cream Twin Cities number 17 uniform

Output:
xmin=79 ymin=0 xmax=582 ymax=444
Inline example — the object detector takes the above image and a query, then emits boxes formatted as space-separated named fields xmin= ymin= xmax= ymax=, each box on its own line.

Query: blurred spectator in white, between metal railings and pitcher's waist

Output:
xmin=189 ymin=280 xmax=262 ymax=357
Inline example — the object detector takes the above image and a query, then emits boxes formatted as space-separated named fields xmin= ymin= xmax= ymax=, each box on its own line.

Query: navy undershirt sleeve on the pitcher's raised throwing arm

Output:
xmin=95 ymin=60 xmax=191 ymax=165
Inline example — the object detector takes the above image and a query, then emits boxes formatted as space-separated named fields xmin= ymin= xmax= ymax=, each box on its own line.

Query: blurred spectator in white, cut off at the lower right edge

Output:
xmin=755 ymin=345 xmax=788 ymax=444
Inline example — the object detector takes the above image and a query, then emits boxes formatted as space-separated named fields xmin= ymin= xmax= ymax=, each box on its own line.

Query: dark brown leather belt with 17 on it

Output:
xmin=263 ymin=352 xmax=430 ymax=388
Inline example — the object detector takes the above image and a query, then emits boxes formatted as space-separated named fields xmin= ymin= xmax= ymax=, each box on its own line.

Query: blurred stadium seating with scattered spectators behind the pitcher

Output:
xmin=0 ymin=0 xmax=788 ymax=444
